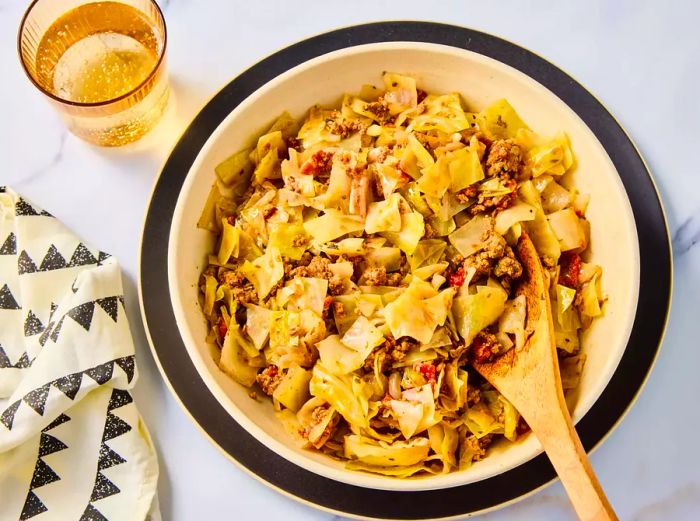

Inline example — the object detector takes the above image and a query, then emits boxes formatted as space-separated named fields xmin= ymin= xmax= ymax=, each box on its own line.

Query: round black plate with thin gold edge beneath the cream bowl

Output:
xmin=140 ymin=22 xmax=671 ymax=519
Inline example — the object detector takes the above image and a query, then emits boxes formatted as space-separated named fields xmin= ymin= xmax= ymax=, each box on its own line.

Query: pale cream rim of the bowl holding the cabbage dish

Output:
xmin=168 ymin=42 xmax=639 ymax=491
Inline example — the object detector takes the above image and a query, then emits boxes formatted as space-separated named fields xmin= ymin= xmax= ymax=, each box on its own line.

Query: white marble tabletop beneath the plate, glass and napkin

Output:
xmin=0 ymin=0 xmax=700 ymax=521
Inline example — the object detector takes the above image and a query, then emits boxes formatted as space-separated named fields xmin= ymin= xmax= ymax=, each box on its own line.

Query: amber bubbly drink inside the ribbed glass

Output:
xmin=36 ymin=2 xmax=167 ymax=146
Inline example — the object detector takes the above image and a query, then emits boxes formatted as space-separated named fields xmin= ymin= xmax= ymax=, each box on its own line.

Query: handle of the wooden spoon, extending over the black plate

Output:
xmin=538 ymin=410 xmax=617 ymax=521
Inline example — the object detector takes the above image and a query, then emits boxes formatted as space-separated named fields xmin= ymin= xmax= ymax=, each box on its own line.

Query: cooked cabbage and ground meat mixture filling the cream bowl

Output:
xmin=198 ymin=73 xmax=604 ymax=477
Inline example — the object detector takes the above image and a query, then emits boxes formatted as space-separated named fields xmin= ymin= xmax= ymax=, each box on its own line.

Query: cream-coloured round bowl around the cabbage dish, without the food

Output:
xmin=168 ymin=42 xmax=639 ymax=490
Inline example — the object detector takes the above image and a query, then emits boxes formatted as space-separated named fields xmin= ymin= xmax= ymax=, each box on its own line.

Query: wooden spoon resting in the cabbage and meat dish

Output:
xmin=473 ymin=232 xmax=617 ymax=521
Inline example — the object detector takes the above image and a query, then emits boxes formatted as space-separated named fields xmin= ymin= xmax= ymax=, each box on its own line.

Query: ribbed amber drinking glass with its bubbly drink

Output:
xmin=17 ymin=0 xmax=169 ymax=146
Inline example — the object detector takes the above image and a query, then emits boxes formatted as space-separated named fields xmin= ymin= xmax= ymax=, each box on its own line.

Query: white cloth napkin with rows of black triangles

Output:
xmin=0 ymin=187 xmax=160 ymax=521
